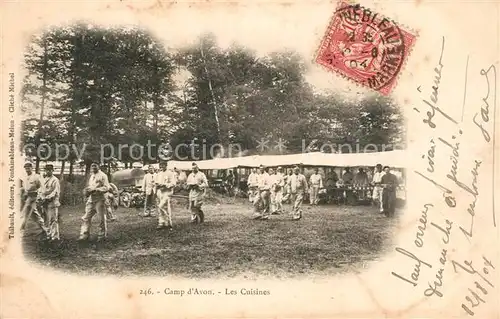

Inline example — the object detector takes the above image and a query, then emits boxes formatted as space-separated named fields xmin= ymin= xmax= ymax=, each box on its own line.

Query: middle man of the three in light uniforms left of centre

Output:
xmin=156 ymin=163 xmax=176 ymax=230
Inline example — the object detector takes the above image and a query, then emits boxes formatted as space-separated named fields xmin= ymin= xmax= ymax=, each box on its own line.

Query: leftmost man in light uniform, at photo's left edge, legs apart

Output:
xmin=21 ymin=163 xmax=49 ymax=238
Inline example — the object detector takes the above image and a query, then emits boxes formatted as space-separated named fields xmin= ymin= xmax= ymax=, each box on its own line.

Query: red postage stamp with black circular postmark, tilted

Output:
xmin=316 ymin=0 xmax=416 ymax=95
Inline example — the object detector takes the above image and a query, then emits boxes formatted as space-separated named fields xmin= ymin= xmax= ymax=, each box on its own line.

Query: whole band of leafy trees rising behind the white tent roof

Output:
xmin=22 ymin=27 xmax=404 ymax=178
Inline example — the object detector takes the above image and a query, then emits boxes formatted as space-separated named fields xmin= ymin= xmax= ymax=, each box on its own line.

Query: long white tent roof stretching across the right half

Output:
xmin=168 ymin=150 xmax=407 ymax=170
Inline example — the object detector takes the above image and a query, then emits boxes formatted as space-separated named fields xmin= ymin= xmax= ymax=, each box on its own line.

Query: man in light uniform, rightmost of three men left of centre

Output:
xmin=186 ymin=163 xmax=208 ymax=223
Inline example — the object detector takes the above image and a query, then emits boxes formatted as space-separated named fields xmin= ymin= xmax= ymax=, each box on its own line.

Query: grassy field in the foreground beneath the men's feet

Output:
xmin=24 ymin=200 xmax=396 ymax=278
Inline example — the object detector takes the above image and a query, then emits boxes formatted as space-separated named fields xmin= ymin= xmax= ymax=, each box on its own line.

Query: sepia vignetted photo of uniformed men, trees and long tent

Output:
xmin=21 ymin=22 xmax=406 ymax=278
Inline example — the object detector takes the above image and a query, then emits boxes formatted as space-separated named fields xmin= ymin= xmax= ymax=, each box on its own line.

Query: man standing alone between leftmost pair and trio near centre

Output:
xmin=79 ymin=163 xmax=110 ymax=241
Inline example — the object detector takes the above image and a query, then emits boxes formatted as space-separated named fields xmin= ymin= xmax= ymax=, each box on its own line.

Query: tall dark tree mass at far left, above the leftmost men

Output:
xmin=24 ymin=23 xmax=178 ymax=174
